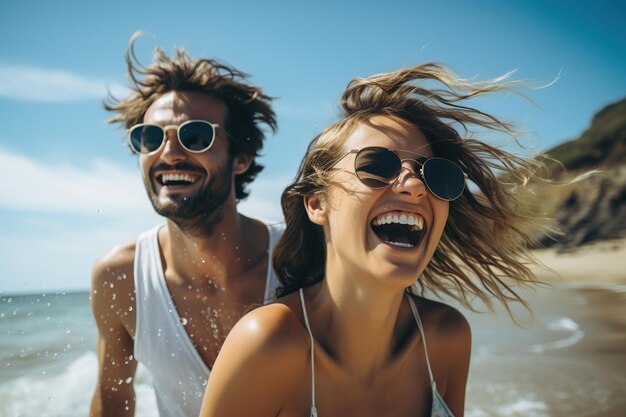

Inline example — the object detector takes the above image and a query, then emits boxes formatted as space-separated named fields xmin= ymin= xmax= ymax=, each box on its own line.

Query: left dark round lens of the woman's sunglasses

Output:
xmin=354 ymin=148 xmax=401 ymax=188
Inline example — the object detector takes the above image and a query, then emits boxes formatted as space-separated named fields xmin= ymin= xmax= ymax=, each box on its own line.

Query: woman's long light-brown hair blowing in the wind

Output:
xmin=273 ymin=63 xmax=547 ymax=312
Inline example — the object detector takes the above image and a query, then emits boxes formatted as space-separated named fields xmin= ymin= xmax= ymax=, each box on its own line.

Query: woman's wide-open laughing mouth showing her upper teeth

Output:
xmin=371 ymin=211 xmax=426 ymax=248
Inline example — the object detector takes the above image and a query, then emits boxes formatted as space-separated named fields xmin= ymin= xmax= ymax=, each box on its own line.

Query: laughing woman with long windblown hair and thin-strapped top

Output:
xmin=201 ymin=64 xmax=541 ymax=417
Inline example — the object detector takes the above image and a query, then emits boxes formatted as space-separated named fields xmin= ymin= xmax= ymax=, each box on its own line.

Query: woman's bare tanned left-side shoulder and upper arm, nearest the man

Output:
xmin=201 ymin=294 xmax=309 ymax=417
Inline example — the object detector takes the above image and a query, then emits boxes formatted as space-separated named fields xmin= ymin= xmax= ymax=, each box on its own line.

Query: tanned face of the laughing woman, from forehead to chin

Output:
xmin=322 ymin=116 xmax=449 ymax=287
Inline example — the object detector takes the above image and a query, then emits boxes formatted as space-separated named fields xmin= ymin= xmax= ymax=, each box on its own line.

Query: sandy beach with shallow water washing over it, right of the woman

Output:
xmin=466 ymin=240 xmax=626 ymax=417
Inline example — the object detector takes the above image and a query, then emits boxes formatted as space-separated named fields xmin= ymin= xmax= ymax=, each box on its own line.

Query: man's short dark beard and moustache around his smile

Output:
xmin=144 ymin=156 xmax=233 ymax=237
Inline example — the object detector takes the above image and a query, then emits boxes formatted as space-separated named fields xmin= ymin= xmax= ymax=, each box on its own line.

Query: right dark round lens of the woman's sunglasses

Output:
xmin=423 ymin=158 xmax=465 ymax=201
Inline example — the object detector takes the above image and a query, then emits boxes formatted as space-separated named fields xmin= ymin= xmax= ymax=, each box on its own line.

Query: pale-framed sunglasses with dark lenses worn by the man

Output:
xmin=128 ymin=120 xmax=219 ymax=154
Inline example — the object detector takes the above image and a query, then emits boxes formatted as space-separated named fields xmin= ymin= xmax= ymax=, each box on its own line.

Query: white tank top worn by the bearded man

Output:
xmin=134 ymin=219 xmax=284 ymax=417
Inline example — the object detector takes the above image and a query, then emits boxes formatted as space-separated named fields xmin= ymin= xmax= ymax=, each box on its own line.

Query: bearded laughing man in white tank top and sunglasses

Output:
xmin=91 ymin=37 xmax=282 ymax=417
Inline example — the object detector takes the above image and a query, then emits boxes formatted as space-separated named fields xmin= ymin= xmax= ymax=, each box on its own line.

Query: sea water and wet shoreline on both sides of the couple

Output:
xmin=0 ymin=284 xmax=626 ymax=417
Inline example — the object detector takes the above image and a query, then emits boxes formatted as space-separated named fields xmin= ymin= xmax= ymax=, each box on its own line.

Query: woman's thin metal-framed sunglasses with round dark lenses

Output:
xmin=337 ymin=146 xmax=467 ymax=201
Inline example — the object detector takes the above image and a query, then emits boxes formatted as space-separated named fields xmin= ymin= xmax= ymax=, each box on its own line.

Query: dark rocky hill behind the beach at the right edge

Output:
xmin=533 ymin=99 xmax=626 ymax=248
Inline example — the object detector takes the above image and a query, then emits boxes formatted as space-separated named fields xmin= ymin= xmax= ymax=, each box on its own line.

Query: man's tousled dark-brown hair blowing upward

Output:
xmin=104 ymin=32 xmax=277 ymax=200
